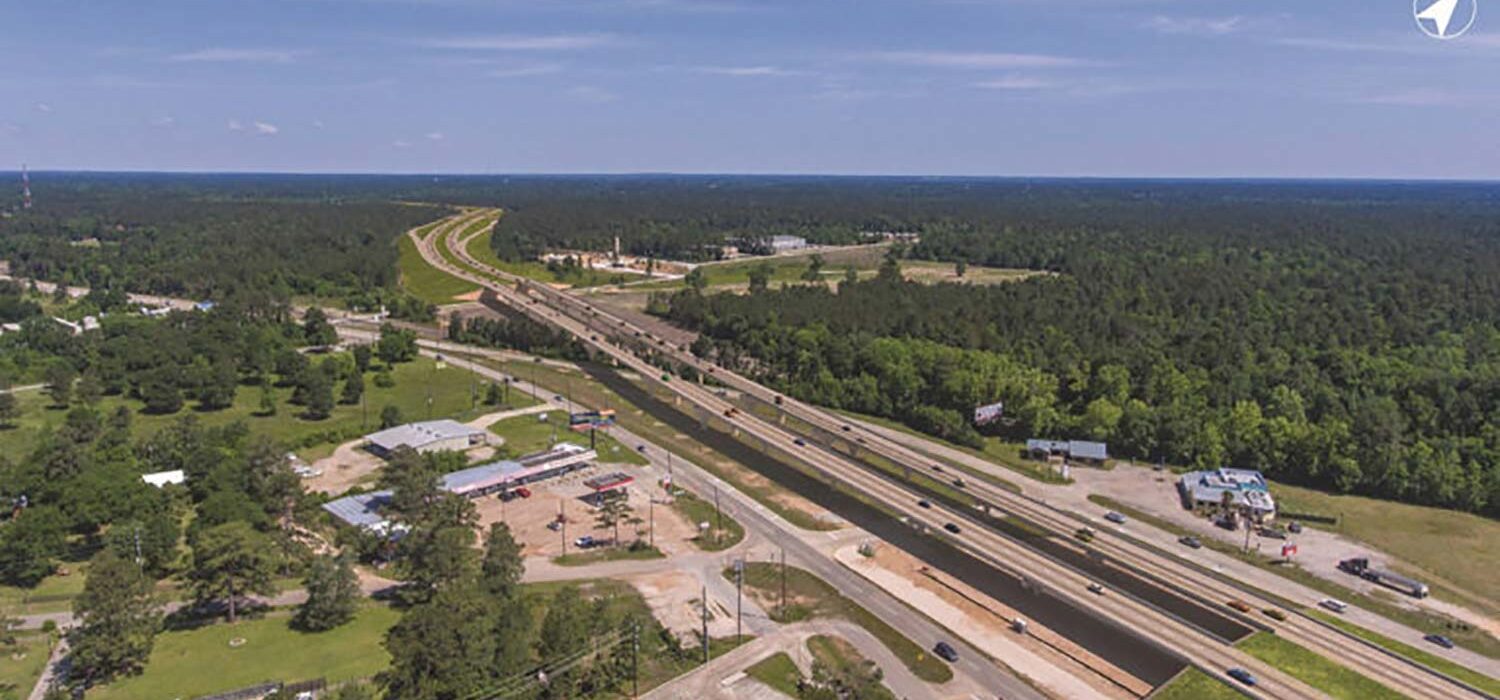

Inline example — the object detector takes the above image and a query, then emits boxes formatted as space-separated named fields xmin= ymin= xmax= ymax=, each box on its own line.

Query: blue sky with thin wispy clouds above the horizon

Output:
xmin=0 ymin=0 xmax=1500 ymax=180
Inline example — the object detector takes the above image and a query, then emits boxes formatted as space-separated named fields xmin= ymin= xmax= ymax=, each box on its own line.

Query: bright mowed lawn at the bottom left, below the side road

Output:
xmin=89 ymin=604 xmax=401 ymax=700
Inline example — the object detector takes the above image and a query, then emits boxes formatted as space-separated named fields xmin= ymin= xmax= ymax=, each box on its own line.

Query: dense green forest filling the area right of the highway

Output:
xmin=668 ymin=184 xmax=1500 ymax=516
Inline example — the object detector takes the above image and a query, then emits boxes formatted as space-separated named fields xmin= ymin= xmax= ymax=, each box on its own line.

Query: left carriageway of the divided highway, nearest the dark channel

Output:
xmin=419 ymin=214 xmax=1323 ymax=697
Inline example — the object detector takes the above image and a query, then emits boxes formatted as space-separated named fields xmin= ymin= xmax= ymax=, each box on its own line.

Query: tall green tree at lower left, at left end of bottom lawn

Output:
xmin=68 ymin=549 xmax=161 ymax=687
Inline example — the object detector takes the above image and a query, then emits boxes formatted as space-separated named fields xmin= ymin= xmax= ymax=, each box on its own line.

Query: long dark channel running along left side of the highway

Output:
xmin=582 ymin=364 xmax=1185 ymax=685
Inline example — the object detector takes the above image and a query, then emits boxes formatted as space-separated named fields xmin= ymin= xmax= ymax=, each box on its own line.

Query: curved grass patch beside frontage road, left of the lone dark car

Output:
xmin=725 ymin=562 xmax=953 ymax=684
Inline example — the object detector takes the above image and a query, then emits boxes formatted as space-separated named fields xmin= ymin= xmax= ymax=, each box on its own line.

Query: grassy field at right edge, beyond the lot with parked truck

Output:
xmin=1272 ymin=484 xmax=1500 ymax=615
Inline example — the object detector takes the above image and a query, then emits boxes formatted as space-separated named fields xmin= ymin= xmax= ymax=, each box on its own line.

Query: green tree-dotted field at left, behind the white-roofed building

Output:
xmin=0 ymin=357 xmax=504 ymax=454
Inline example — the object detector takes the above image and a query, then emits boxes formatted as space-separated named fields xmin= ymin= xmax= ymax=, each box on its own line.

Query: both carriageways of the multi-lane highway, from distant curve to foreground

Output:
xmin=419 ymin=213 xmax=1485 ymax=697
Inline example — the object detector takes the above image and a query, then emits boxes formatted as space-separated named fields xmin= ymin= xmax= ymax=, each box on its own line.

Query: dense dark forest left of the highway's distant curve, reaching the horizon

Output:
xmin=0 ymin=174 xmax=443 ymax=307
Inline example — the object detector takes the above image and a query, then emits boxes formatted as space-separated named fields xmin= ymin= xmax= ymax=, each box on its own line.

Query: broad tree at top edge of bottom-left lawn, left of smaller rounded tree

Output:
xmin=188 ymin=522 xmax=276 ymax=622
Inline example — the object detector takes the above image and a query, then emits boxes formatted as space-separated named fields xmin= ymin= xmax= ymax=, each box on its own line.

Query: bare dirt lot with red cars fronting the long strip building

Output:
xmin=474 ymin=465 xmax=696 ymax=558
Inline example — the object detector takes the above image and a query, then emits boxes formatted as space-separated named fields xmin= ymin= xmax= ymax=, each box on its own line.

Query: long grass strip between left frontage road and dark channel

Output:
xmin=492 ymin=360 xmax=837 ymax=529
